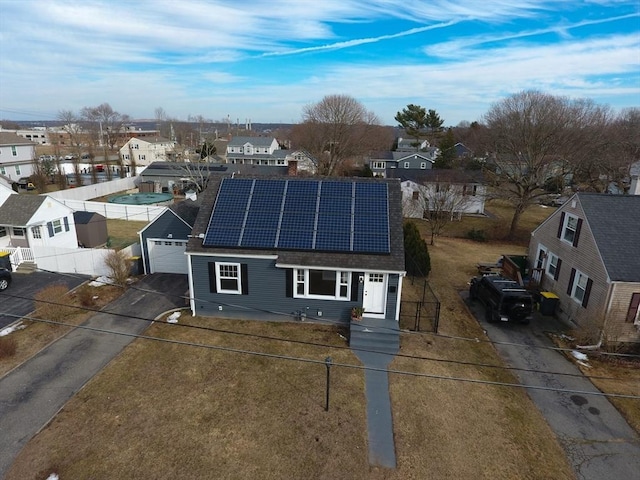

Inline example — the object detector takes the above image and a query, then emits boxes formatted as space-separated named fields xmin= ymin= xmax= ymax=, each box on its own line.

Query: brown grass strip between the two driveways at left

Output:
xmin=0 ymin=285 xmax=122 ymax=377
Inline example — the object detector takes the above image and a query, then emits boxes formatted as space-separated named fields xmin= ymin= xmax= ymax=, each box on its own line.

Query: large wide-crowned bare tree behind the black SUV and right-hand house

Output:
xmin=484 ymin=91 xmax=606 ymax=237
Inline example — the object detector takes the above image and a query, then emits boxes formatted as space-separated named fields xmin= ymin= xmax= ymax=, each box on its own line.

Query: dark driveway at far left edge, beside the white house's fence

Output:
xmin=0 ymin=271 xmax=89 ymax=330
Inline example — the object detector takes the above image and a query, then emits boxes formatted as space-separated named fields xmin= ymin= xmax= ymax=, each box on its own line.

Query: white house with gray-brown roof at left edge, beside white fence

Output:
xmin=0 ymin=195 xmax=78 ymax=248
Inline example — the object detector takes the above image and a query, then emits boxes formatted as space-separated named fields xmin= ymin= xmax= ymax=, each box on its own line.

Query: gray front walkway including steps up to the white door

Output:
xmin=350 ymin=318 xmax=400 ymax=468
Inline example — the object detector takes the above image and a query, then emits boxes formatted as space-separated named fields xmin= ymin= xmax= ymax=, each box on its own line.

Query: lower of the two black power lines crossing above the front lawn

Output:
xmin=7 ymin=315 xmax=640 ymax=400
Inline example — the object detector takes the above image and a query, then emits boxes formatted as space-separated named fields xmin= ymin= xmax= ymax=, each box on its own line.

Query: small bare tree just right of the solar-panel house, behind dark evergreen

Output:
xmin=403 ymin=181 xmax=469 ymax=245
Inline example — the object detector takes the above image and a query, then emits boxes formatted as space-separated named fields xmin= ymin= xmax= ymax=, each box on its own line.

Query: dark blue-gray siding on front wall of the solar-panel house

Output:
xmin=191 ymin=255 xmax=398 ymax=324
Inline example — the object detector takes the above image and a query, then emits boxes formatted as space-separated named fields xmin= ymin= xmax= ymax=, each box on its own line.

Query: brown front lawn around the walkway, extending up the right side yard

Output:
xmin=2 ymin=203 xmax=584 ymax=480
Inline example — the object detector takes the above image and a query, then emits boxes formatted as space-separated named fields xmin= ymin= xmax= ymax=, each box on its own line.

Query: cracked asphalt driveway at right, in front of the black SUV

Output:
xmin=462 ymin=292 xmax=640 ymax=480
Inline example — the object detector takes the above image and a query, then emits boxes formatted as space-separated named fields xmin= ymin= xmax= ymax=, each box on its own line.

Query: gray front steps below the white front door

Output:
xmin=349 ymin=318 xmax=400 ymax=355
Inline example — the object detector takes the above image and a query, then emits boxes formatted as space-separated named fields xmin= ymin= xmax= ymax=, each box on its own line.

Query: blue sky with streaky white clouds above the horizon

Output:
xmin=0 ymin=0 xmax=640 ymax=125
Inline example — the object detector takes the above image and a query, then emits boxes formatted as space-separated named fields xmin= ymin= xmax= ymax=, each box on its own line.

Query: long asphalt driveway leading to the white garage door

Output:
xmin=0 ymin=274 xmax=187 ymax=478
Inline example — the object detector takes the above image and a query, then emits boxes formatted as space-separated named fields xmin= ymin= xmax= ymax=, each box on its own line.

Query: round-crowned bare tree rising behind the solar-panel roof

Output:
xmin=292 ymin=95 xmax=380 ymax=175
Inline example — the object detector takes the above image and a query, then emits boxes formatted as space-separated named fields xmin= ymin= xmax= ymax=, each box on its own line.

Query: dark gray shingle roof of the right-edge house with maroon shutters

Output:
xmin=577 ymin=193 xmax=640 ymax=282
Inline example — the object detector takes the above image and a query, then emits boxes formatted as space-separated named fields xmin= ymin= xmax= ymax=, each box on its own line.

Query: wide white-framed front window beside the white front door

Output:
xmin=294 ymin=268 xmax=351 ymax=300
